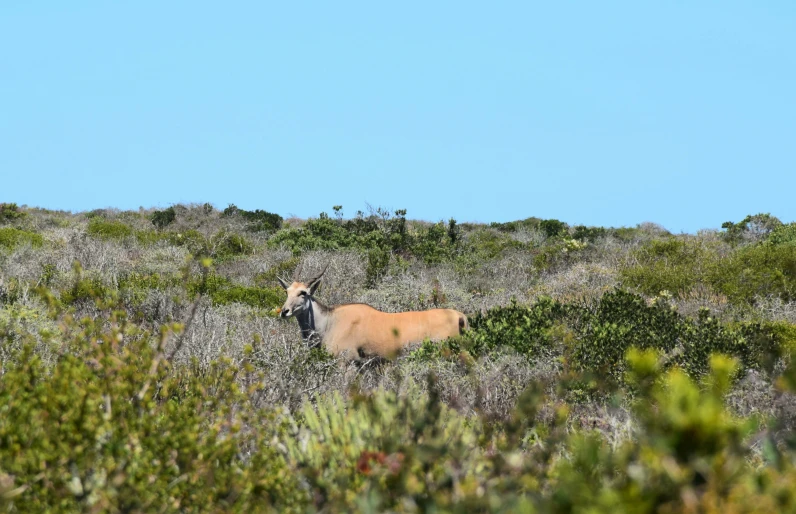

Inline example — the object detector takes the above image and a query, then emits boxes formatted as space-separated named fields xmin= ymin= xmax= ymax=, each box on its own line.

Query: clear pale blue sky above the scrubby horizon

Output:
xmin=0 ymin=0 xmax=796 ymax=232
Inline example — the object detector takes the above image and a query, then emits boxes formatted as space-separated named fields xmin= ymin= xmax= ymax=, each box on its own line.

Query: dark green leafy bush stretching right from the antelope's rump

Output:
xmin=412 ymin=289 xmax=796 ymax=381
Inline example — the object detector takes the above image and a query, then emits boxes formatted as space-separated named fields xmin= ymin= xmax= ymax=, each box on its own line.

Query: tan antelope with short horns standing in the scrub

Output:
xmin=277 ymin=264 xmax=468 ymax=359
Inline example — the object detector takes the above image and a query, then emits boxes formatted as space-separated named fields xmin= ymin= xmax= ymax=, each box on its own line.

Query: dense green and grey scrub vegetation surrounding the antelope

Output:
xmin=0 ymin=203 xmax=796 ymax=512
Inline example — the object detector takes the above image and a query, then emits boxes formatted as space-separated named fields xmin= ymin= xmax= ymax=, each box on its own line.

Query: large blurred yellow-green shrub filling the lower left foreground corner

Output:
xmin=0 ymin=300 xmax=307 ymax=512
